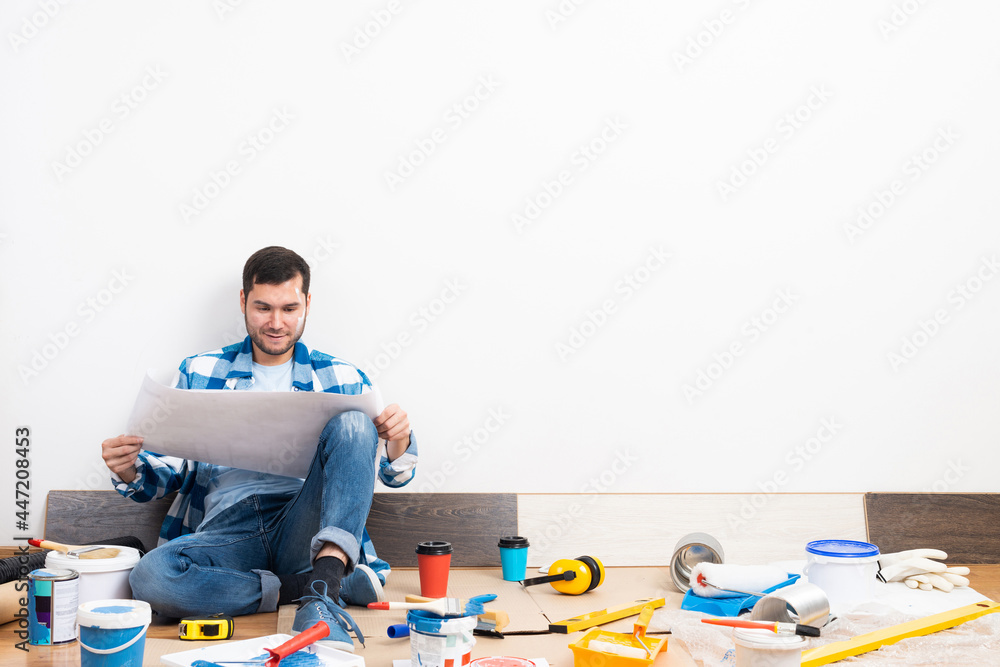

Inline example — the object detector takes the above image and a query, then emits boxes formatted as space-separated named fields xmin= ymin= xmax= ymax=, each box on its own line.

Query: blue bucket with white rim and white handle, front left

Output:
xmin=76 ymin=600 xmax=152 ymax=667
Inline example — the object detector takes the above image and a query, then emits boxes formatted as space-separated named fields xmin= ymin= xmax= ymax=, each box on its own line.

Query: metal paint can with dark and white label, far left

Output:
xmin=28 ymin=569 xmax=80 ymax=646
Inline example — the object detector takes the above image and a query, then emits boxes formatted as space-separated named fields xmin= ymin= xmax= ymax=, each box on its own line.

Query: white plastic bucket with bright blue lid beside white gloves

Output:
xmin=805 ymin=540 xmax=879 ymax=614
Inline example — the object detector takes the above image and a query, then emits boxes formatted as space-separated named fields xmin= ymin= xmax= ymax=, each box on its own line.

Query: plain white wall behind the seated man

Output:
xmin=0 ymin=0 xmax=1000 ymax=534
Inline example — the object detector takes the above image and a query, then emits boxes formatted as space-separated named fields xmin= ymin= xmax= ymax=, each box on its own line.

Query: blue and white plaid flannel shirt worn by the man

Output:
xmin=111 ymin=336 xmax=417 ymax=578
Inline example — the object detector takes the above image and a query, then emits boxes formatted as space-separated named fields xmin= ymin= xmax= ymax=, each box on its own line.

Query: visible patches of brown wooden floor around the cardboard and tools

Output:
xmin=0 ymin=565 xmax=1000 ymax=667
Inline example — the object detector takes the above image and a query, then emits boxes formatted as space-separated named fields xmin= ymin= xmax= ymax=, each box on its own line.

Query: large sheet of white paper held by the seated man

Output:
xmin=126 ymin=372 xmax=383 ymax=477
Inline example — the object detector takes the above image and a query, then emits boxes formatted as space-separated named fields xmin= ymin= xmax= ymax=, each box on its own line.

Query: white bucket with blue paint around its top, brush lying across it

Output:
xmin=406 ymin=609 xmax=478 ymax=667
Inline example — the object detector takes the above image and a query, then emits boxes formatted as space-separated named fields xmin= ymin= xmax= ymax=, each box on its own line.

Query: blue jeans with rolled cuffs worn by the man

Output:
xmin=129 ymin=412 xmax=378 ymax=617
